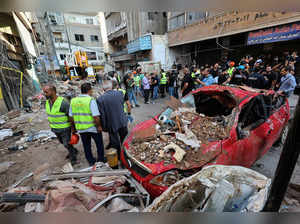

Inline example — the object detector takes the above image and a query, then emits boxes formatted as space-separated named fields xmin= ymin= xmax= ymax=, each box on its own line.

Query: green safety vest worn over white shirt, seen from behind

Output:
xmin=71 ymin=96 xmax=95 ymax=130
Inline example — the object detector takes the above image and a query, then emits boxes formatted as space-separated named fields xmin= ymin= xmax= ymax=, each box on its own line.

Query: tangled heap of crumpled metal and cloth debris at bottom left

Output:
xmin=0 ymin=163 xmax=150 ymax=212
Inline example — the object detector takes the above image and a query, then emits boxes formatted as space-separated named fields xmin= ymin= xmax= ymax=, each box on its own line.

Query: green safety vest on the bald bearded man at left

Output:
xmin=46 ymin=96 xmax=71 ymax=129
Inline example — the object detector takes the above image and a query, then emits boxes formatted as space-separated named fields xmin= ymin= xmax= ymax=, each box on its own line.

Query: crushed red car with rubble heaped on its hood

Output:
xmin=121 ymin=85 xmax=290 ymax=197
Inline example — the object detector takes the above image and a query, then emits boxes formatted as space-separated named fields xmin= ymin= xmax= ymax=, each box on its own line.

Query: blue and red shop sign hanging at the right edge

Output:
xmin=247 ymin=22 xmax=300 ymax=45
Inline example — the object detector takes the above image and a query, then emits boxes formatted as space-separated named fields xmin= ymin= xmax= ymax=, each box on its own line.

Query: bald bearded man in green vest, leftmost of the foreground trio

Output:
xmin=43 ymin=85 xmax=78 ymax=165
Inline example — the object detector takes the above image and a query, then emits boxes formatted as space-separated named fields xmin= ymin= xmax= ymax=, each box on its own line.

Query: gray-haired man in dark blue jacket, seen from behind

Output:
xmin=97 ymin=81 xmax=128 ymax=158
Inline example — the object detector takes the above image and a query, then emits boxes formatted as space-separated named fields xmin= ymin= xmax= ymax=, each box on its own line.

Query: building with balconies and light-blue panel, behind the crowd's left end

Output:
xmin=105 ymin=11 xmax=167 ymax=74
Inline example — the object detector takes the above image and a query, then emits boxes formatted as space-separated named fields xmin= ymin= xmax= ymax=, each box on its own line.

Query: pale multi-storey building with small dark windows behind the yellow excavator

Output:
xmin=35 ymin=12 xmax=105 ymax=75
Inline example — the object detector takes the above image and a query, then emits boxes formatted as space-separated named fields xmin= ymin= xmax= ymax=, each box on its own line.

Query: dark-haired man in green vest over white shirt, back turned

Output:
xmin=69 ymin=83 xmax=104 ymax=166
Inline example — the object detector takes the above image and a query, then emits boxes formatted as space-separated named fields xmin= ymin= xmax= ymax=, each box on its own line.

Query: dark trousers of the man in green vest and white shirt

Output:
xmin=80 ymin=132 xmax=104 ymax=166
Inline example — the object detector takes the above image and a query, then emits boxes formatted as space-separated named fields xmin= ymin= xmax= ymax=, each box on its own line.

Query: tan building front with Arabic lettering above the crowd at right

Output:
xmin=168 ymin=11 xmax=300 ymax=65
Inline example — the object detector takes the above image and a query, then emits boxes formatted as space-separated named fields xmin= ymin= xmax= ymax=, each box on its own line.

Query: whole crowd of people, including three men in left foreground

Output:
xmin=43 ymin=52 xmax=299 ymax=165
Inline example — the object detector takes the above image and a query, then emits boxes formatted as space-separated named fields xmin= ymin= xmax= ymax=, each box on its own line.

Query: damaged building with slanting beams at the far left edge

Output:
xmin=0 ymin=12 xmax=40 ymax=114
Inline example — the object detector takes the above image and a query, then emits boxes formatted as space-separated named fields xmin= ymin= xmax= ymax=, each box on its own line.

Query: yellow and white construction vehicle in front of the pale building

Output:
xmin=65 ymin=51 xmax=95 ymax=80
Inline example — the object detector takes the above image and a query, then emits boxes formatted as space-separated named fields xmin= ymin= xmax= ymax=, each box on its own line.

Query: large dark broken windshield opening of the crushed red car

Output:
xmin=194 ymin=91 xmax=237 ymax=117
